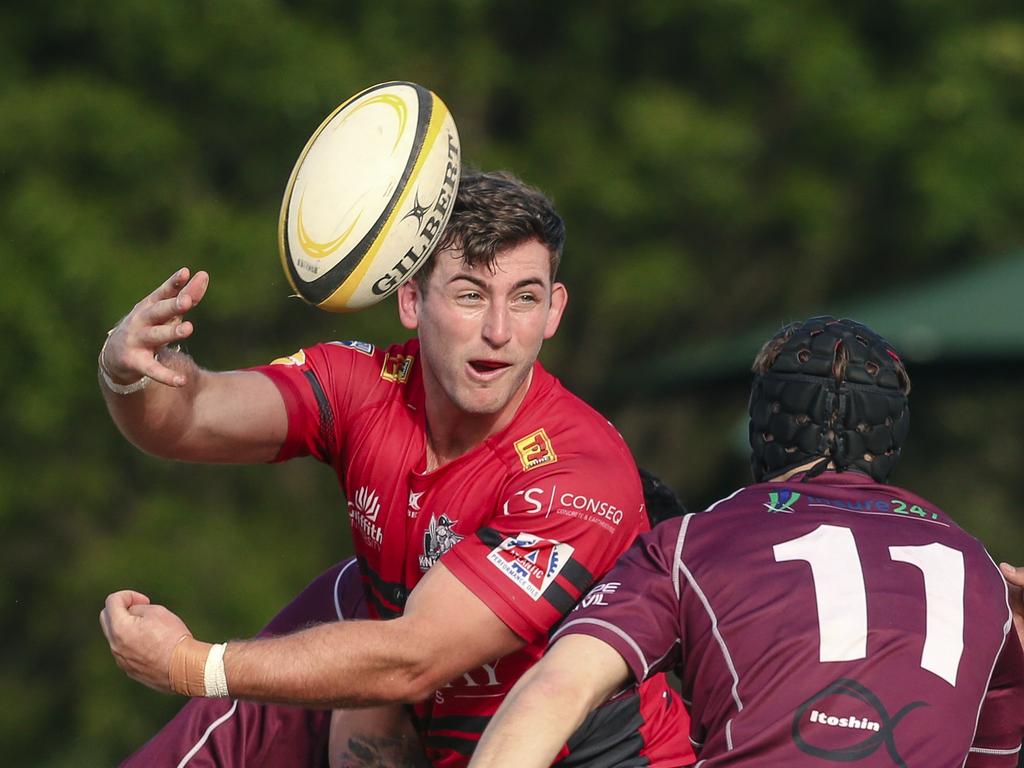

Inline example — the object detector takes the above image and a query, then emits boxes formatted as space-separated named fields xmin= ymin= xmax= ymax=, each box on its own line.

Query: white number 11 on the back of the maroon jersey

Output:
xmin=774 ymin=525 xmax=964 ymax=686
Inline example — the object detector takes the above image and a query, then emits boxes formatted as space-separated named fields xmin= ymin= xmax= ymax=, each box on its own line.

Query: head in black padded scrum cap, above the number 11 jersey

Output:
xmin=750 ymin=316 xmax=910 ymax=482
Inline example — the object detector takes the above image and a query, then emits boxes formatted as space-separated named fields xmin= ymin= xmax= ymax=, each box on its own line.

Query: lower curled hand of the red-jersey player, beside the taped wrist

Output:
xmin=99 ymin=590 xmax=191 ymax=692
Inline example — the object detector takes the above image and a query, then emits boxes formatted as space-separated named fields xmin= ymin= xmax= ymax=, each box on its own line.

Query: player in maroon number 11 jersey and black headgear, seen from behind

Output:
xmin=471 ymin=317 xmax=1024 ymax=768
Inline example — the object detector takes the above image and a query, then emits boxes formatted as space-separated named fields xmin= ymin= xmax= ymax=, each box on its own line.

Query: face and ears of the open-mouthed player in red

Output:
xmin=398 ymin=240 xmax=566 ymax=417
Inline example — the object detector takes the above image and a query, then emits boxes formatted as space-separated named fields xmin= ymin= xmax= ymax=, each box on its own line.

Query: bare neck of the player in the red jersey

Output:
xmin=424 ymin=370 xmax=534 ymax=472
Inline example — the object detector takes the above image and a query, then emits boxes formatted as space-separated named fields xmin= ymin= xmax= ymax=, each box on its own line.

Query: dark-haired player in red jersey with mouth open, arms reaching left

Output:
xmin=100 ymin=174 xmax=692 ymax=767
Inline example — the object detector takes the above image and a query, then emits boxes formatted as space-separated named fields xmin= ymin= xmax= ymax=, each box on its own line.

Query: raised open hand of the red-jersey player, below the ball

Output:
xmin=100 ymin=267 xmax=210 ymax=387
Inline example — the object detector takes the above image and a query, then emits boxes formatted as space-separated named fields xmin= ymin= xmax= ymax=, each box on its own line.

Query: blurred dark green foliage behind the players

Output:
xmin=0 ymin=0 xmax=1024 ymax=766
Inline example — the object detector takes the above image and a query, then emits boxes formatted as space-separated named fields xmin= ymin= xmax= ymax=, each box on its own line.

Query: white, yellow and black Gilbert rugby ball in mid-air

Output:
xmin=278 ymin=82 xmax=460 ymax=312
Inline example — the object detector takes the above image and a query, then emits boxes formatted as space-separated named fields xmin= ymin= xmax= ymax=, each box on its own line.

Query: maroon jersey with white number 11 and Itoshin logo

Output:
xmin=554 ymin=472 xmax=1024 ymax=768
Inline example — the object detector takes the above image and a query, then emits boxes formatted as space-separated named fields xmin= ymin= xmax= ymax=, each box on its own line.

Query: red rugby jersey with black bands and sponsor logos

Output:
xmin=257 ymin=340 xmax=692 ymax=767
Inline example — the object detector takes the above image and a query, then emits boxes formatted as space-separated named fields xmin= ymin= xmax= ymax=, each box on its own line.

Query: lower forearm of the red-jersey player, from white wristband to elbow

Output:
xmin=224 ymin=620 xmax=438 ymax=709
